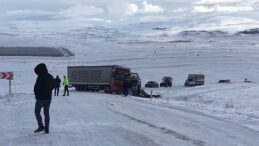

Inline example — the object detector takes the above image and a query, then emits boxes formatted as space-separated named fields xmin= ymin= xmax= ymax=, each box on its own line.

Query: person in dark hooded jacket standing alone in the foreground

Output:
xmin=34 ymin=63 xmax=54 ymax=134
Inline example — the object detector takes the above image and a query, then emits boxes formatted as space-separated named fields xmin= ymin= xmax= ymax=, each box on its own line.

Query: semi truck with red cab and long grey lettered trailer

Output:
xmin=67 ymin=65 xmax=130 ymax=93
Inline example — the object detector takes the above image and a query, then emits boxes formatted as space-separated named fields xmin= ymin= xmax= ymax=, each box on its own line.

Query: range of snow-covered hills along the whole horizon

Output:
xmin=0 ymin=16 xmax=259 ymax=44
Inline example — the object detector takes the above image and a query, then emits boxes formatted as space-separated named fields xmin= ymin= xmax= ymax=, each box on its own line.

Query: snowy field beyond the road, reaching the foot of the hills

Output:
xmin=0 ymin=22 xmax=259 ymax=145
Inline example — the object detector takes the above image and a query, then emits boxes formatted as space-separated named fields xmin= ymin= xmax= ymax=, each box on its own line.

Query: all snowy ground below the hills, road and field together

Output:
xmin=0 ymin=29 xmax=259 ymax=146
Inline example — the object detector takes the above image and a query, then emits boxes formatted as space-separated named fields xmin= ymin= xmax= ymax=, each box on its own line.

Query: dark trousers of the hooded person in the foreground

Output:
xmin=34 ymin=100 xmax=51 ymax=129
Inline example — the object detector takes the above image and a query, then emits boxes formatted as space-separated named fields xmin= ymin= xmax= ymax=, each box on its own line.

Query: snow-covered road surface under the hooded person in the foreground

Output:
xmin=0 ymin=92 xmax=259 ymax=146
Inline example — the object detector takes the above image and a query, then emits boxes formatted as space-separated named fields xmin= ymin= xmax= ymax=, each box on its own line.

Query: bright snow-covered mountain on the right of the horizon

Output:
xmin=119 ymin=16 xmax=259 ymax=37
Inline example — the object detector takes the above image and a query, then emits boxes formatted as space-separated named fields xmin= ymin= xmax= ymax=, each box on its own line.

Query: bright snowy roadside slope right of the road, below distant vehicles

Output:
xmin=160 ymin=83 xmax=259 ymax=117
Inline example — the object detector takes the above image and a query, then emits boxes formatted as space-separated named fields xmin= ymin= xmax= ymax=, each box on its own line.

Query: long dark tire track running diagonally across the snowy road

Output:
xmin=108 ymin=108 xmax=207 ymax=146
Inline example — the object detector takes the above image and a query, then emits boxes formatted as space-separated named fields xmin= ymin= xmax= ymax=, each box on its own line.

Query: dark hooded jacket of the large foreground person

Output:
xmin=34 ymin=63 xmax=54 ymax=100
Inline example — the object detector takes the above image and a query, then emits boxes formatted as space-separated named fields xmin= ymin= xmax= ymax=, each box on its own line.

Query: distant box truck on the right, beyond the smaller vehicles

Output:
xmin=184 ymin=74 xmax=205 ymax=87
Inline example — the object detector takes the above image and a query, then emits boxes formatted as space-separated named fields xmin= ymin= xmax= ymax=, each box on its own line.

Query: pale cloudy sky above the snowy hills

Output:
xmin=0 ymin=0 xmax=259 ymax=30
